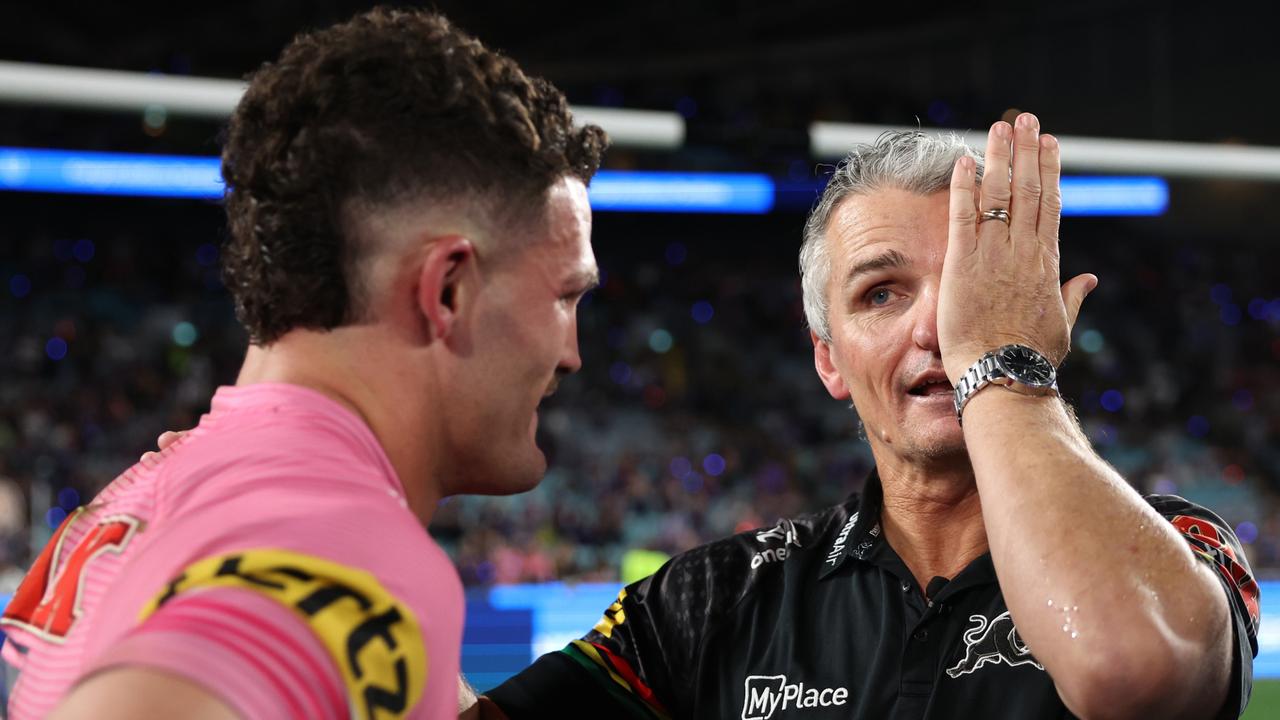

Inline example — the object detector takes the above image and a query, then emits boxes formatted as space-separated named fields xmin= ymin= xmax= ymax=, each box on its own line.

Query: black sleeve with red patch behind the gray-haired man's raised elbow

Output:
xmin=1146 ymin=495 xmax=1262 ymax=717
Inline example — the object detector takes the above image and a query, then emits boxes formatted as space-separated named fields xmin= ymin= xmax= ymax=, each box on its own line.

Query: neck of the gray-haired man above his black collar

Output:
xmin=877 ymin=448 xmax=988 ymax=588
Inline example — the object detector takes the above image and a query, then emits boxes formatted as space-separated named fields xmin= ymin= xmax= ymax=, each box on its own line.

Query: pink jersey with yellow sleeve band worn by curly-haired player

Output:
xmin=3 ymin=384 xmax=463 ymax=720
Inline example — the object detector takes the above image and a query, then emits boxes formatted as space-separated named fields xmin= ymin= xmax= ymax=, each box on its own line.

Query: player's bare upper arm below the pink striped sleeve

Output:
xmin=49 ymin=667 xmax=239 ymax=720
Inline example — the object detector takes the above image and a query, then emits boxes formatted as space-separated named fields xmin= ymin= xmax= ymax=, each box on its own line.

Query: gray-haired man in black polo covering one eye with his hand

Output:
xmin=471 ymin=114 xmax=1258 ymax=720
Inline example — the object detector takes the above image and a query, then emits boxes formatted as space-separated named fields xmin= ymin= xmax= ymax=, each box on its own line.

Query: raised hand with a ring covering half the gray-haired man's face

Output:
xmin=938 ymin=113 xmax=1098 ymax=383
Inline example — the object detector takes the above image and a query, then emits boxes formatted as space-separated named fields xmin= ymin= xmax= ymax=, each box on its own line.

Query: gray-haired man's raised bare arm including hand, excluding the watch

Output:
xmin=938 ymin=115 xmax=1233 ymax=717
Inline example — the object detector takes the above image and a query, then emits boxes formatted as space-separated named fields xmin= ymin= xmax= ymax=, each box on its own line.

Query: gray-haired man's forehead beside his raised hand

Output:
xmin=827 ymin=187 xmax=948 ymax=266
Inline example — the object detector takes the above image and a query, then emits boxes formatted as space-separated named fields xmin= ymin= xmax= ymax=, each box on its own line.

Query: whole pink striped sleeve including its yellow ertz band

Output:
xmin=90 ymin=547 xmax=435 ymax=720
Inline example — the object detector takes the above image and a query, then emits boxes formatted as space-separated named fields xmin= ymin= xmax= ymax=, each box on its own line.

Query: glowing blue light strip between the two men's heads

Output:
xmin=589 ymin=170 xmax=774 ymax=214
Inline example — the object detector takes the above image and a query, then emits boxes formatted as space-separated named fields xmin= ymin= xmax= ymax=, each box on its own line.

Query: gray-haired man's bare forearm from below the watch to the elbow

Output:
xmin=964 ymin=388 xmax=1230 ymax=717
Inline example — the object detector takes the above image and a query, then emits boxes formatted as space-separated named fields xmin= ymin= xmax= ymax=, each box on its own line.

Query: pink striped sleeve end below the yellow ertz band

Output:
xmin=88 ymin=588 xmax=349 ymax=720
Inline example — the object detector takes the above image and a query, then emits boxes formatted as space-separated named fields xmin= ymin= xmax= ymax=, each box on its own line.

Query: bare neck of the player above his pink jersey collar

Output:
xmin=236 ymin=325 xmax=440 ymax=527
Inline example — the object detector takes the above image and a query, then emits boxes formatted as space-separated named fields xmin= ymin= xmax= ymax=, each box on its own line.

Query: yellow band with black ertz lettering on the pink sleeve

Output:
xmin=138 ymin=550 xmax=428 ymax=720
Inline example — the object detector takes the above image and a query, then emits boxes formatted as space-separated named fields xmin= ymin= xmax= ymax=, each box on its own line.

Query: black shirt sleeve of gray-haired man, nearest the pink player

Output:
xmin=485 ymin=537 xmax=754 ymax=720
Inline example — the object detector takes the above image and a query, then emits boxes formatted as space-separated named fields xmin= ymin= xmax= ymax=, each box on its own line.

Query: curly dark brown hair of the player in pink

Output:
xmin=223 ymin=8 xmax=607 ymax=345
